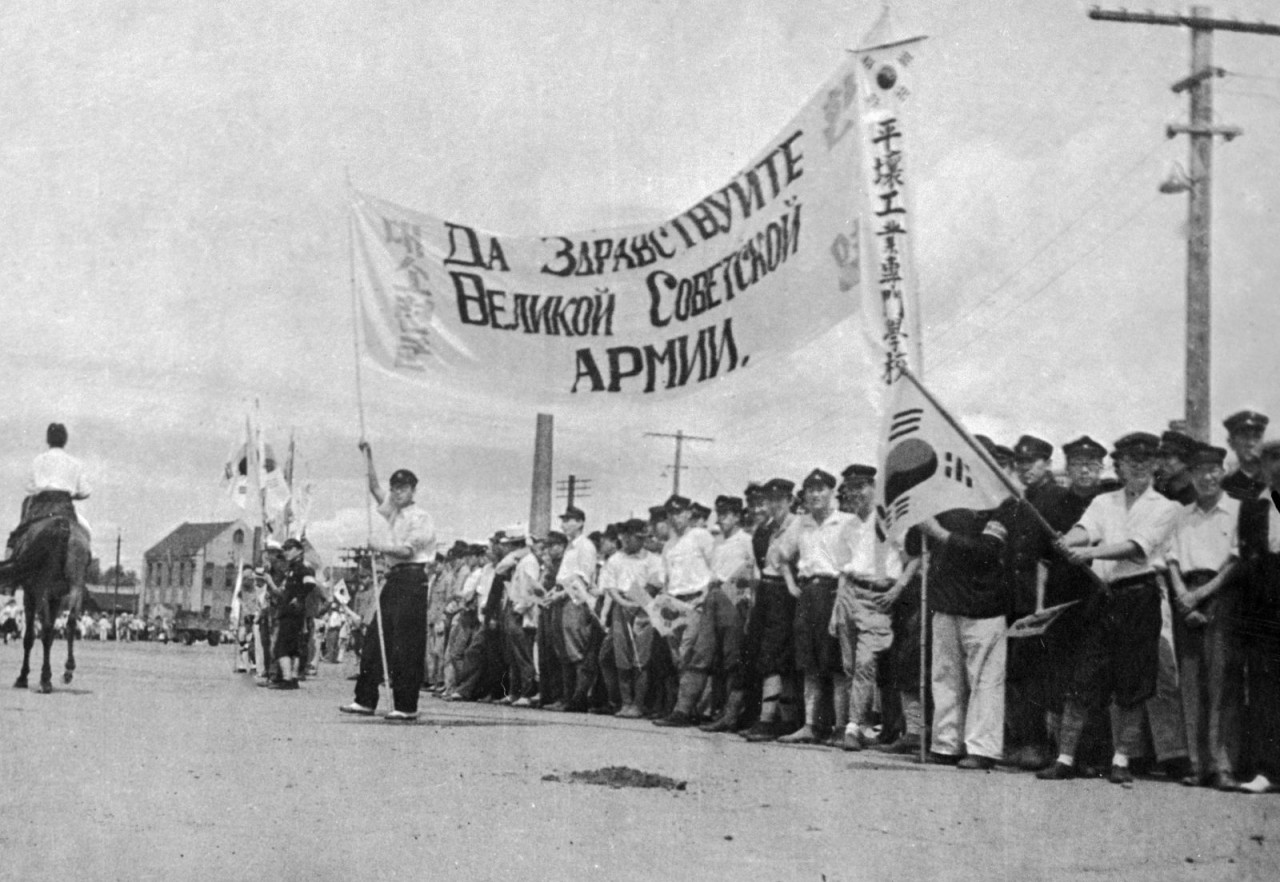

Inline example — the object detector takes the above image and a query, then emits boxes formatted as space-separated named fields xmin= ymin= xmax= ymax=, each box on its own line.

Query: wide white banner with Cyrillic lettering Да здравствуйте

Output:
xmin=352 ymin=58 xmax=861 ymax=398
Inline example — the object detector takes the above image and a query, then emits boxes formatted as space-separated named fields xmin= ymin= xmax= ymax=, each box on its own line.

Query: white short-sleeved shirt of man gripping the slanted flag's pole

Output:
xmin=1076 ymin=486 xmax=1181 ymax=581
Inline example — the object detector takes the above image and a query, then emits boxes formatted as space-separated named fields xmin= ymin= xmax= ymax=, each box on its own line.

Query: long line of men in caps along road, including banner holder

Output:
xmin=317 ymin=411 xmax=1280 ymax=792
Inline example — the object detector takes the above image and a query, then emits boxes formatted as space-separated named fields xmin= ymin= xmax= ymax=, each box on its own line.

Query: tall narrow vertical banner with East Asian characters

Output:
xmin=855 ymin=6 xmax=924 ymax=383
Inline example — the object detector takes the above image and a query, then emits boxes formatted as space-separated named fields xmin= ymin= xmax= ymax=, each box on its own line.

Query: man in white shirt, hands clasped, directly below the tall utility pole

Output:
xmin=1169 ymin=444 xmax=1243 ymax=790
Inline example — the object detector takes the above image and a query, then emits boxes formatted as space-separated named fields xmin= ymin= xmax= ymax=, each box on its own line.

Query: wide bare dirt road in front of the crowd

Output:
xmin=0 ymin=643 xmax=1280 ymax=882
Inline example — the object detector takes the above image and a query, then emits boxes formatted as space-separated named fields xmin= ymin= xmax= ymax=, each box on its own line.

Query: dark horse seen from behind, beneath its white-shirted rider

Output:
xmin=0 ymin=494 xmax=90 ymax=694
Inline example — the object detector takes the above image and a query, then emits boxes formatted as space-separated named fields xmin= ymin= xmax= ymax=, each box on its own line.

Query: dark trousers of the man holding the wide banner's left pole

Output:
xmin=356 ymin=567 xmax=426 ymax=713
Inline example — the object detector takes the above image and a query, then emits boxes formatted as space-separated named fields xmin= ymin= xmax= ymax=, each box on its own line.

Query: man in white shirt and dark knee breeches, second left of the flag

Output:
xmin=771 ymin=469 xmax=854 ymax=744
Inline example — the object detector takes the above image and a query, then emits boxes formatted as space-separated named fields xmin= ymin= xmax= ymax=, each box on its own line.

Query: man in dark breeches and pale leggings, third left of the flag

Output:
xmin=742 ymin=477 xmax=796 ymax=741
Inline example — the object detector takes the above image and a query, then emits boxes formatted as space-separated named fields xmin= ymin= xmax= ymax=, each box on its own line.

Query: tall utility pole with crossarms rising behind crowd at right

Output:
xmin=1089 ymin=6 xmax=1280 ymax=442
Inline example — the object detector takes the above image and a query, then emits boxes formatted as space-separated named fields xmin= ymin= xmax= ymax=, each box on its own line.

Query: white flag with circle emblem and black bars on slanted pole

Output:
xmin=878 ymin=370 xmax=1014 ymax=544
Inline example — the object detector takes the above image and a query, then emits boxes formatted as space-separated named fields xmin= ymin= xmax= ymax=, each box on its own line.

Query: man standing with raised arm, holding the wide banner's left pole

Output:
xmin=340 ymin=440 xmax=435 ymax=722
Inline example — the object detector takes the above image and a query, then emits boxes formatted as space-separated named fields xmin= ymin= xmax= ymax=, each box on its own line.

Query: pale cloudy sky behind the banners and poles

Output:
xmin=0 ymin=0 xmax=1280 ymax=568
